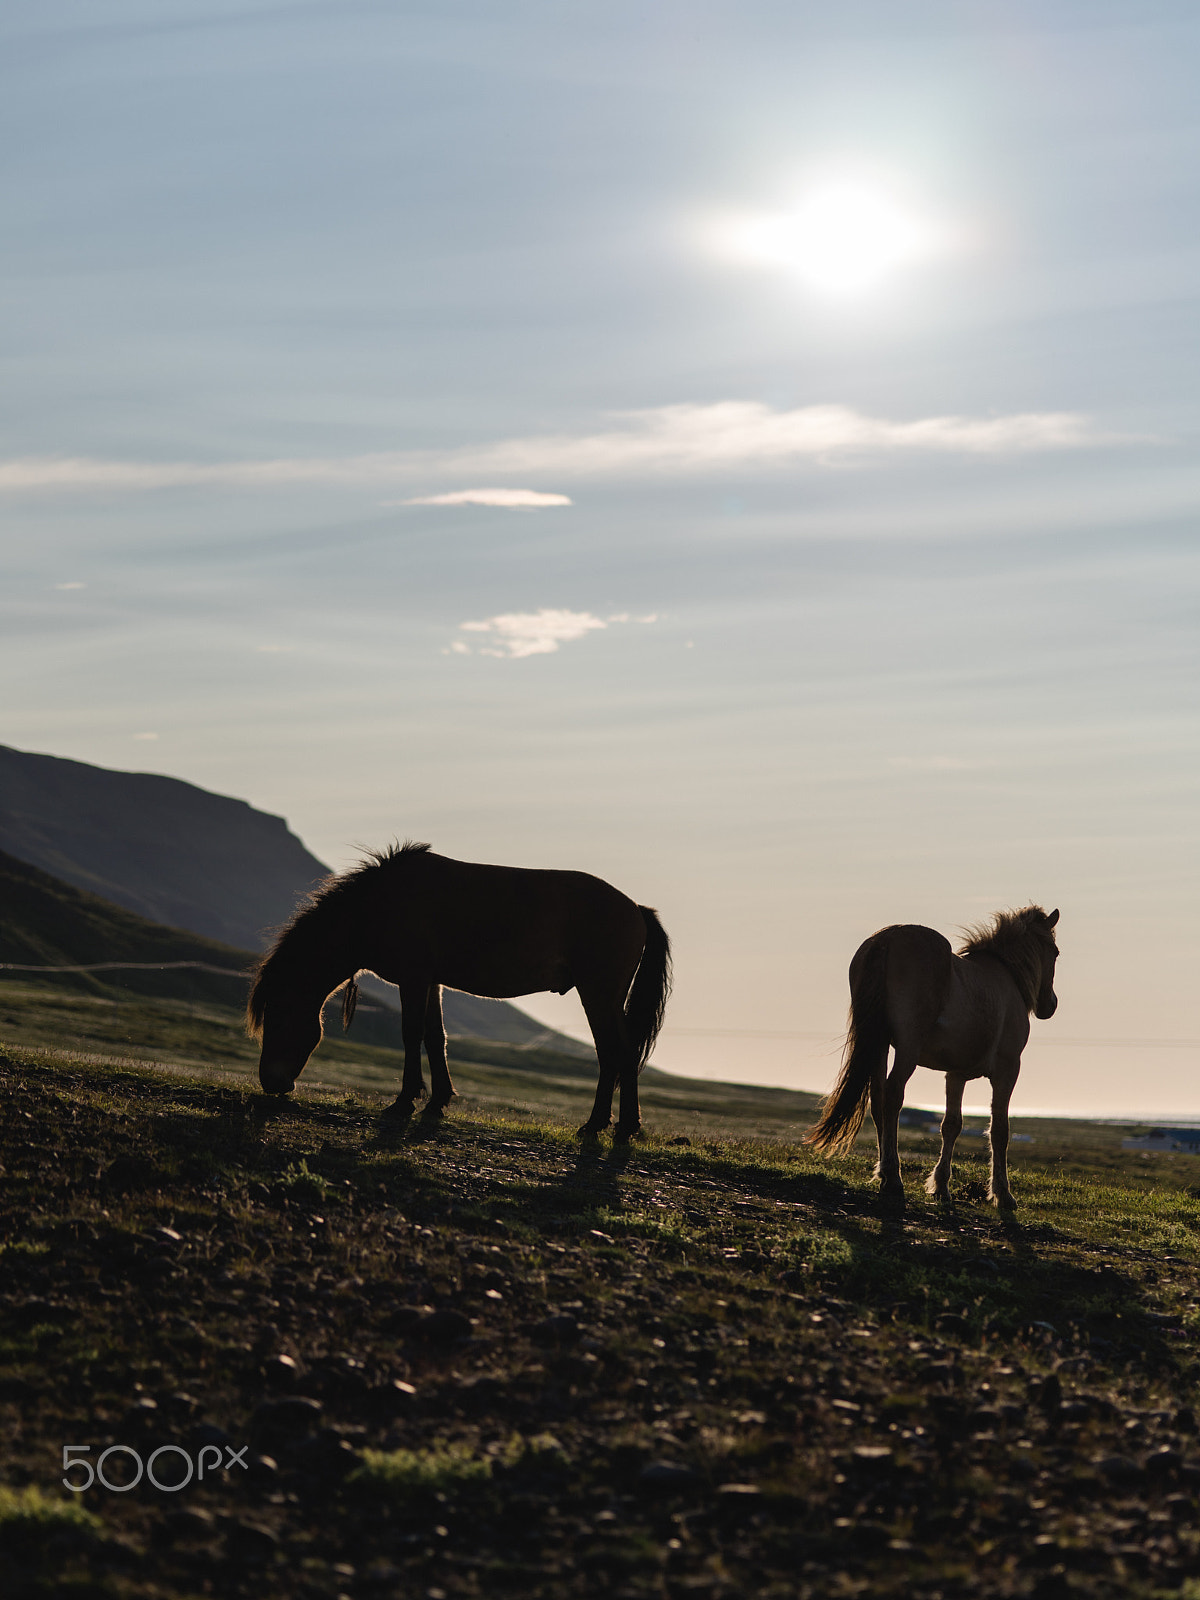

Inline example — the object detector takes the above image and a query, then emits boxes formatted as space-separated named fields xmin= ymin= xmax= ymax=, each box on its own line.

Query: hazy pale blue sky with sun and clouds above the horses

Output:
xmin=0 ymin=0 xmax=1200 ymax=1115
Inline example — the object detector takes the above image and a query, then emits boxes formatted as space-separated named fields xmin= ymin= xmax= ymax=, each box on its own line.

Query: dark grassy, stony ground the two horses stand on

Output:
xmin=0 ymin=986 xmax=1200 ymax=1600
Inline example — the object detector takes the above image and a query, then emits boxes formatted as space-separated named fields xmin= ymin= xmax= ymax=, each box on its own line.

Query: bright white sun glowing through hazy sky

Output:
xmin=723 ymin=182 xmax=938 ymax=294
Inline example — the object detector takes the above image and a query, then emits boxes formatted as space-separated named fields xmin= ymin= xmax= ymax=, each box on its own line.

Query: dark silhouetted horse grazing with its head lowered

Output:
xmin=246 ymin=843 xmax=670 ymax=1139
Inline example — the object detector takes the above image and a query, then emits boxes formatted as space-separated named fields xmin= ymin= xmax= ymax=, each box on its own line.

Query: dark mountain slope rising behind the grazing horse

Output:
xmin=0 ymin=744 xmax=592 ymax=1056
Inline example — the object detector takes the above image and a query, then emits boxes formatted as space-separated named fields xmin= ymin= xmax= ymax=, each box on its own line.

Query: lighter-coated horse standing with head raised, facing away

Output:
xmin=806 ymin=906 xmax=1058 ymax=1211
